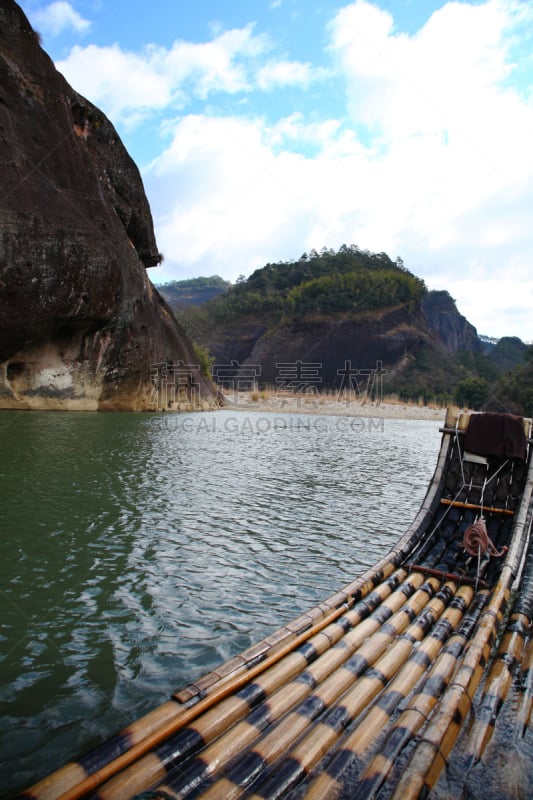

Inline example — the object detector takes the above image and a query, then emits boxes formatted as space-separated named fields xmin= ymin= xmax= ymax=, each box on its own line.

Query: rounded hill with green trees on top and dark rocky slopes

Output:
xmin=162 ymin=245 xmax=528 ymax=410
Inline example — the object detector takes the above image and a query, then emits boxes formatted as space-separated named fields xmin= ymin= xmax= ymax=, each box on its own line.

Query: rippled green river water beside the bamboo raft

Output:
xmin=0 ymin=411 xmax=440 ymax=796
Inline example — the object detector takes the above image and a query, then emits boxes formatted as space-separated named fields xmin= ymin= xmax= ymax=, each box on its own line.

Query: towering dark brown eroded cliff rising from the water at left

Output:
xmin=0 ymin=0 xmax=213 ymax=409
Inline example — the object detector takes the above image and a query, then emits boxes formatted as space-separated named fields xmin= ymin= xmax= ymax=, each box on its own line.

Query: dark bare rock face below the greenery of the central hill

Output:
xmin=201 ymin=303 xmax=452 ymax=391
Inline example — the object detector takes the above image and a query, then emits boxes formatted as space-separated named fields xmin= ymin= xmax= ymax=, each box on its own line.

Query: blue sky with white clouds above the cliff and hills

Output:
xmin=20 ymin=0 xmax=533 ymax=341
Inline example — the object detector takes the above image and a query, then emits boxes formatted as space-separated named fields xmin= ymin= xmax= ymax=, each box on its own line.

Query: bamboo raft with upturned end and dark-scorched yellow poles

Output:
xmin=22 ymin=409 xmax=533 ymax=800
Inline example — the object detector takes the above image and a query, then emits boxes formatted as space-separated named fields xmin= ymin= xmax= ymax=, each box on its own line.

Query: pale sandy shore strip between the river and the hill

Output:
xmin=225 ymin=392 xmax=446 ymax=422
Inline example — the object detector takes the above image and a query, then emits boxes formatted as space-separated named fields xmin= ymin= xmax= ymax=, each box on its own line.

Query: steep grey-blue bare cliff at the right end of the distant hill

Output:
xmin=422 ymin=290 xmax=483 ymax=353
